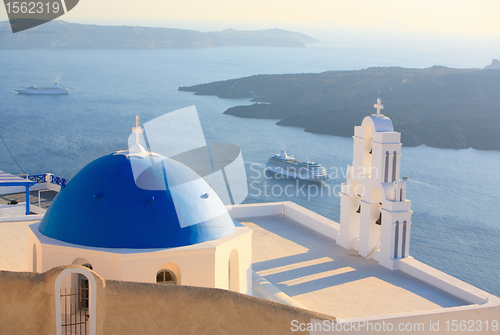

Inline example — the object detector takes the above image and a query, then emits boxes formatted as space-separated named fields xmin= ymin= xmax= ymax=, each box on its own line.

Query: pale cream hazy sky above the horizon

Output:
xmin=0 ymin=0 xmax=500 ymax=36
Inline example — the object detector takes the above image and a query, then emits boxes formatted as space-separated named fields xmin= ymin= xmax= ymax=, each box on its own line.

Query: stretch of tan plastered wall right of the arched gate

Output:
xmin=103 ymin=281 xmax=333 ymax=334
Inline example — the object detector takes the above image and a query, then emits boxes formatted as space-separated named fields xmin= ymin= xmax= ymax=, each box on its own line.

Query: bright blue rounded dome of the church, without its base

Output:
xmin=39 ymin=152 xmax=235 ymax=249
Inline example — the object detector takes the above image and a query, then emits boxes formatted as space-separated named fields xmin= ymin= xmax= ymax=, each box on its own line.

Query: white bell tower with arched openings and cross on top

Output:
xmin=337 ymin=98 xmax=413 ymax=270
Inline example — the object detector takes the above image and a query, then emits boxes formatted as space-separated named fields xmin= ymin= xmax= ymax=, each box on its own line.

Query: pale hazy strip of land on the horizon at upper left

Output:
xmin=0 ymin=20 xmax=319 ymax=49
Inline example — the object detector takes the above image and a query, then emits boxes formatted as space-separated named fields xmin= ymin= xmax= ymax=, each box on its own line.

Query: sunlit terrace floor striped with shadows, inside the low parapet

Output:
xmin=239 ymin=215 xmax=467 ymax=318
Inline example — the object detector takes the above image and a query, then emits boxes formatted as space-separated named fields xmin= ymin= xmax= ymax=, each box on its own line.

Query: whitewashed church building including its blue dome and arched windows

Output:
xmin=25 ymin=125 xmax=252 ymax=294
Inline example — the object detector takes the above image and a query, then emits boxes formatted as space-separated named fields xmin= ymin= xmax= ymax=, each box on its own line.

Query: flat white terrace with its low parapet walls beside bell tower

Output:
xmin=230 ymin=202 xmax=500 ymax=320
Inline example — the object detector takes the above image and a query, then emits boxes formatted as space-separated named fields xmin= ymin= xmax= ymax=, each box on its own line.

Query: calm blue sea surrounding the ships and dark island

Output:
xmin=0 ymin=45 xmax=500 ymax=295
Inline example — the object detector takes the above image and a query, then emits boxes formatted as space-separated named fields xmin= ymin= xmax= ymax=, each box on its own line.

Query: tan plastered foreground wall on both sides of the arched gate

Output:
xmin=0 ymin=266 xmax=334 ymax=335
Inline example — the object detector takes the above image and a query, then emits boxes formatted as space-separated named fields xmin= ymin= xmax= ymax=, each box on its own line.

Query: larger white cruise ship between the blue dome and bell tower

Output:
xmin=266 ymin=151 xmax=328 ymax=183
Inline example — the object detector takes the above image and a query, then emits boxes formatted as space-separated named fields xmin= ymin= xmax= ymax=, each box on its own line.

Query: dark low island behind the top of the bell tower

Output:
xmin=179 ymin=61 xmax=500 ymax=150
